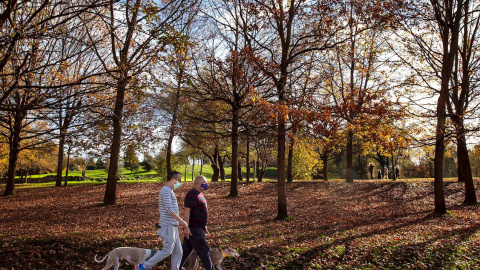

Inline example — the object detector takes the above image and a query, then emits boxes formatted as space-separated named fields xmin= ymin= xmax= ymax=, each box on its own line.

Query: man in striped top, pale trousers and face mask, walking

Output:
xmin=139 ymin=171 xmax=188 ymax=270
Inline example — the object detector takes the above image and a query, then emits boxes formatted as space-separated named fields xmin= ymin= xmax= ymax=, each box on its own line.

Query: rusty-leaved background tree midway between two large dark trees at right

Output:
xmin=323 ymin=2 xmax=404 ymax=182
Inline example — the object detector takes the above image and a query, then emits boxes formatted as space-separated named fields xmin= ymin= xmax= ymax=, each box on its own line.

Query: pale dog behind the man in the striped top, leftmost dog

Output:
xmin=95 ymin=247 xmax=155 ymax=270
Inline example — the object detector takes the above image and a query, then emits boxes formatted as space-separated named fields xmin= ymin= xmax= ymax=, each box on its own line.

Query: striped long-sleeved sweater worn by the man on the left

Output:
xmin=158 ymin=185 xmax=179 ymax=227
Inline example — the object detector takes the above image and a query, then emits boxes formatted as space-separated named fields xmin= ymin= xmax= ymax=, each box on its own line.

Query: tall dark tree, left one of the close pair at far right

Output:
xmin=402 ymin=0 xmax=467 ymax=214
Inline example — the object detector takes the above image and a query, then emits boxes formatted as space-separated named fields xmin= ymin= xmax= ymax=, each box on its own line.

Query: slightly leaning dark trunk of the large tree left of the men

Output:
xmin=103 ymin=79 xmax=127 ymax=205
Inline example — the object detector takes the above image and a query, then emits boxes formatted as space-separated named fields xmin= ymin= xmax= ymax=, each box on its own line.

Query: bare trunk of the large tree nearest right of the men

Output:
xmin=275 ymin=117 xmax=288 ymax=220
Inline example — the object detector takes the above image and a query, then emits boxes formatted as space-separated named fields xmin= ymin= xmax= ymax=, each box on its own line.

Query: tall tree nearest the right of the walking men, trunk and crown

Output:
xmin=242 ymin=0 xmax=343 ymax=220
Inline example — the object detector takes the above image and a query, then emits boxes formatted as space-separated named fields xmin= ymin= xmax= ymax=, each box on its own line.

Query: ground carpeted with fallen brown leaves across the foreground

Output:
xmin=0 ymin=179 xmax=480 ymax=270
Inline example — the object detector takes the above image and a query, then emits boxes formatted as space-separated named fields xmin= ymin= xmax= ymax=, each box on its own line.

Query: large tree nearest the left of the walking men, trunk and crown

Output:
xmin=86 ymin=0 xmax=196 ymax=205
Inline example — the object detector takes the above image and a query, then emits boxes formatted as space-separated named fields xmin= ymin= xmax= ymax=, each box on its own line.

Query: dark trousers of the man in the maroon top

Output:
xmin=180 ymin=227 xmax=214 ymax=270
